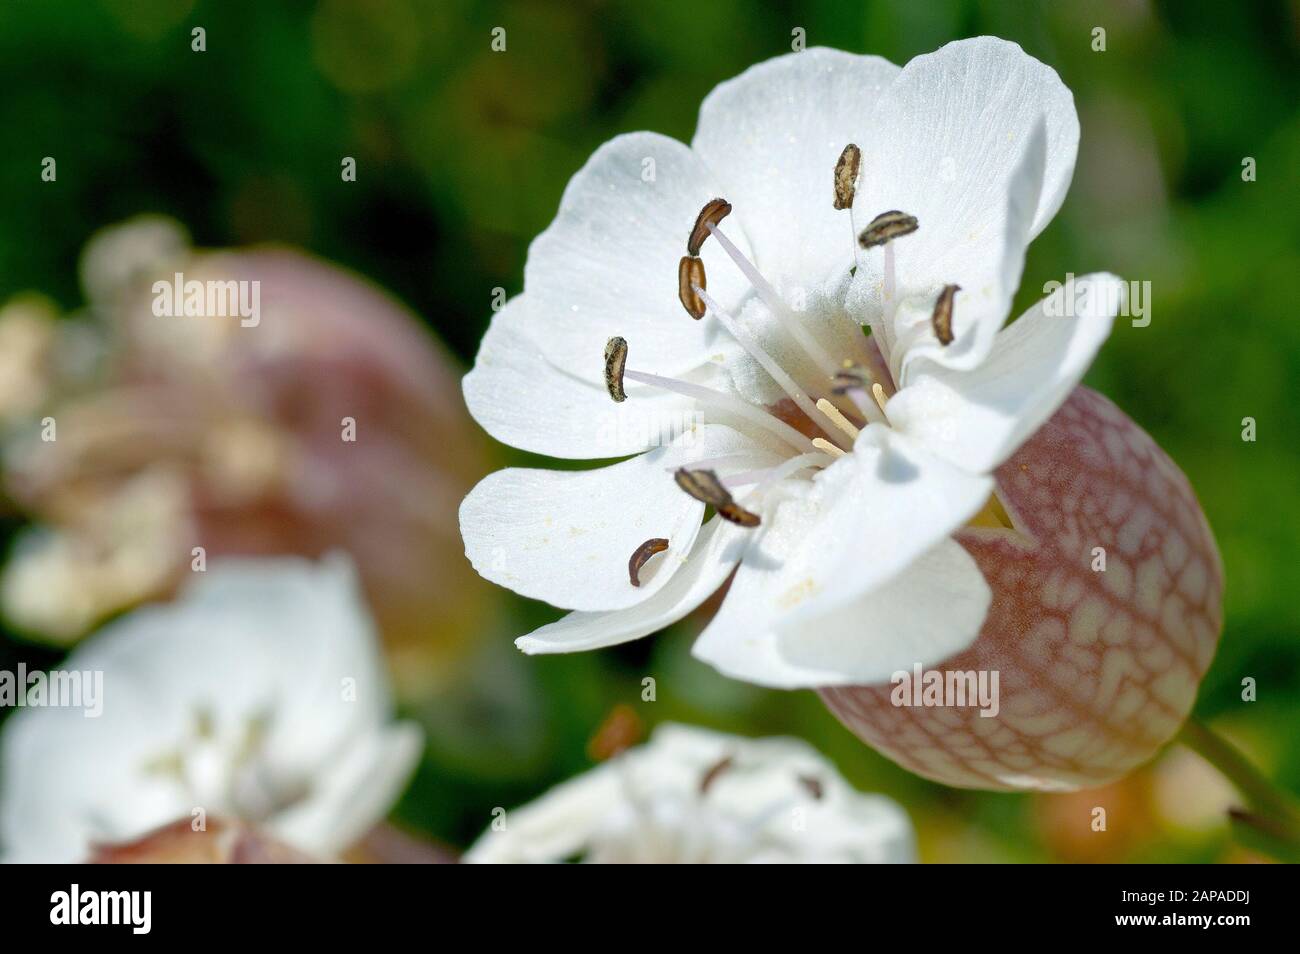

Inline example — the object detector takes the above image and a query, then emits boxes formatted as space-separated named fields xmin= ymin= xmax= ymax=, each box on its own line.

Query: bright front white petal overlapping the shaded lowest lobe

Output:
xmin=693 ymin=434 xmax=993 ymax=688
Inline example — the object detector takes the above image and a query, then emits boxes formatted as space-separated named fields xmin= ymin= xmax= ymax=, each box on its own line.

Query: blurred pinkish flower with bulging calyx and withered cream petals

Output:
xmin=0 ymin=216 xmax=490 ymax=693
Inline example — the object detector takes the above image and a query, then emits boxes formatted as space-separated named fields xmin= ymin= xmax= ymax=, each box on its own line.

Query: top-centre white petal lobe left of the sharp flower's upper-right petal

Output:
xmin=692 ymin=48 xmax=898 ymax=282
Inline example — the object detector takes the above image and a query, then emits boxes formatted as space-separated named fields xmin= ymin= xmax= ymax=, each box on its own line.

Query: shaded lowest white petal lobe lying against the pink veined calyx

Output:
xmin=777 ymin=539 xmax=992 ymax=685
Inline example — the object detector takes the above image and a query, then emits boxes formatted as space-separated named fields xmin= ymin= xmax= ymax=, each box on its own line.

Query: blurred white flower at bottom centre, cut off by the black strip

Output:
xmin=465 ymin=724 xmax=914 ymax=864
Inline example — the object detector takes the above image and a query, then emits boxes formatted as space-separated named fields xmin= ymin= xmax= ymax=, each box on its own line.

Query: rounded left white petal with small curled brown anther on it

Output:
xmin=460 ymin=425 xmax=775 ymax=611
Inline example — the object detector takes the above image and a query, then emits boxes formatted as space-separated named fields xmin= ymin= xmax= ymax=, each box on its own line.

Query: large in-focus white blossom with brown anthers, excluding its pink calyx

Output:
xmin=460 ymin=38 xmax=1118 ymax=686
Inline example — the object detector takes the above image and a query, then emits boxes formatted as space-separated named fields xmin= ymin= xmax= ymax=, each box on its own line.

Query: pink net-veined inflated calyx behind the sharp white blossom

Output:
xmin=822 ymin=387 xmax=1223 ymax=790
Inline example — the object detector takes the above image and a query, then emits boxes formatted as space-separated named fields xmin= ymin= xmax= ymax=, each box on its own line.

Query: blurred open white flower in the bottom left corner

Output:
xmin=0 ymin=558 xmax=420 ymax=862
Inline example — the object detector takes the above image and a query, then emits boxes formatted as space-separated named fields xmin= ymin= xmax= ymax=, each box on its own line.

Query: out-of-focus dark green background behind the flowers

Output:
xmin=0 ymin=0 xmax=1300 ymax=860
